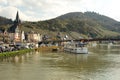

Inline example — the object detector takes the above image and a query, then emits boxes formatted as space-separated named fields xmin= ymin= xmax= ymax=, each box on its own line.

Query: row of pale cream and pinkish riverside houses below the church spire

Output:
xmin=0 ymin=31 xmax=42 ymax=43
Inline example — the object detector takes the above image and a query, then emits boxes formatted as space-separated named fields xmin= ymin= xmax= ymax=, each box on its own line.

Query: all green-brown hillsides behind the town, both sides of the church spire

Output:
xmin=0 ymin=12 xmax=120 ymax=38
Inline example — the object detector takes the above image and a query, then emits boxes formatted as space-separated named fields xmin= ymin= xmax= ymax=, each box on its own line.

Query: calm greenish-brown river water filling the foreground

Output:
xmin=0 ymin=46 xmax=120 ymax=80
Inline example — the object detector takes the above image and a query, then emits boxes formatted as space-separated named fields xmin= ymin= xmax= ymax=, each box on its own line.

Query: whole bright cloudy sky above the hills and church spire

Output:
xmin=0 ymin=0 xmax=120 ymax=21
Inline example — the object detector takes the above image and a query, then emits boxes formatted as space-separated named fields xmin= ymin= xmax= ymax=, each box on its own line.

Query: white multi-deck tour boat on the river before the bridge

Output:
xmin=64 ymin=42 xmax=88 ymax=54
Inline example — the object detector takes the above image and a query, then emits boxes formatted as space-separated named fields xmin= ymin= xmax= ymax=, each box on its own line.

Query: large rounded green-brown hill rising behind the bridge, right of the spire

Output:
xmin=23 ymin=12 xmax=120 ymax=37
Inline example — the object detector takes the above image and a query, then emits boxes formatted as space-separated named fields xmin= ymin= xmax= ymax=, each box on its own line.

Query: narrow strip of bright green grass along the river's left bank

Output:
xmin=0 ymin=49 xmax=33 ymax=58
